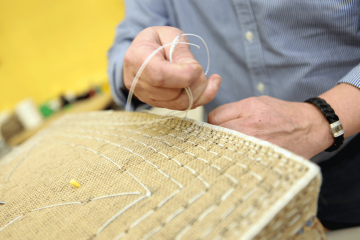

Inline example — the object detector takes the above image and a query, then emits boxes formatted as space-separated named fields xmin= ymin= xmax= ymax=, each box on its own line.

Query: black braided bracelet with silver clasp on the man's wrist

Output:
xmin=305 ymin=97 xmax=344 ymax=152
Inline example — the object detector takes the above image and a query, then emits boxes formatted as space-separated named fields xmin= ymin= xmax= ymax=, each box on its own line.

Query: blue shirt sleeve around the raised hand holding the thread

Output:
xmin=108 ymin=0 xmax=169 ymax=110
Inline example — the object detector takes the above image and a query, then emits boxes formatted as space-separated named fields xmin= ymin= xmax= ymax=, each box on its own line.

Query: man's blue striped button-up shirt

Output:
xmin=108 ymin=0 xmax=360 ymax=161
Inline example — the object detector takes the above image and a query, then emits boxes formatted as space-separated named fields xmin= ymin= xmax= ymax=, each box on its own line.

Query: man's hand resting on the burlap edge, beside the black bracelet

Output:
xmin=208 ymin=96 xmax=334 ymax=159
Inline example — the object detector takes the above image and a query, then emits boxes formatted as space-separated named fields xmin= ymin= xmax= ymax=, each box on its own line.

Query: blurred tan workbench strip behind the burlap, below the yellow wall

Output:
xmin=8 ymin=93 xmax=112 ymax=147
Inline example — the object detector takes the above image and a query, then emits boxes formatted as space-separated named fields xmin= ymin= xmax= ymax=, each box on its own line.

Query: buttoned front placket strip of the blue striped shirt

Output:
xmin=233 ymin=0 xmax=271 ymax=96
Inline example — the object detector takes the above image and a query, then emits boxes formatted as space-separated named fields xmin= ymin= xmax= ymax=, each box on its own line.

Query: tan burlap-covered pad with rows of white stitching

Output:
xmin=0 ymin=112 xmax=321 ymax=239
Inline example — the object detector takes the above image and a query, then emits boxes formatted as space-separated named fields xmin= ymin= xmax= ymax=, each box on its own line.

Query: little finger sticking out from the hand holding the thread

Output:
xmin=194 ymin=74 xmax=221 ymax=108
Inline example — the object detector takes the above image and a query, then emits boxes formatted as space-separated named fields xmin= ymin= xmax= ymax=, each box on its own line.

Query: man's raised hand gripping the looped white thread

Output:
xmin=123 ymin=27 xmax=221 ymax=110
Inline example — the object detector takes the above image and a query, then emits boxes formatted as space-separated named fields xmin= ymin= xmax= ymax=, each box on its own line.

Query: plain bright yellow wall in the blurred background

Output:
xmin=0 ymin=0 xmax=124 ymax=111
